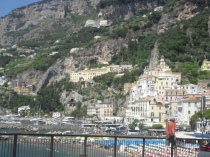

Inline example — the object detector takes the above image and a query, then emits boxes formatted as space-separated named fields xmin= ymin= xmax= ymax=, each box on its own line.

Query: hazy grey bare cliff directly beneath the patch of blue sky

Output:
xmin=0 ymin=0 xmax=98 ymax=45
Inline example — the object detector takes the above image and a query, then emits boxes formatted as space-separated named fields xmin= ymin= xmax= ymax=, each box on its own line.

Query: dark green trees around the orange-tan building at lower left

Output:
xmin=0 ymin=79 xmax=77 ymax=115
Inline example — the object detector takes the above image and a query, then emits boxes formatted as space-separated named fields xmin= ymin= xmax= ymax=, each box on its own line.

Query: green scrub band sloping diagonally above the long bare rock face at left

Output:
xmin=7 ymin=27 xmax=107 ymax=76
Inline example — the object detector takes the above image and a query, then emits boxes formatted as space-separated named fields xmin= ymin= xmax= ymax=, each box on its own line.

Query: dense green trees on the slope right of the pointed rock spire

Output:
xmin=158 ymin=9 xmax=210 ymax=83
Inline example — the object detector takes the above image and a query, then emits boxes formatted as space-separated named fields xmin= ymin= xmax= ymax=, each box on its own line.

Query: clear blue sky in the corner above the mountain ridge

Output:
xmin=0 ymin=0 xmax=41 ymax=17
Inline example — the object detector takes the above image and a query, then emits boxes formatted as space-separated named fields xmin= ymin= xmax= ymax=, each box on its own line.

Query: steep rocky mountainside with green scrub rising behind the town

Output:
xmin=0 ymin=0 xmax=210 ymax=114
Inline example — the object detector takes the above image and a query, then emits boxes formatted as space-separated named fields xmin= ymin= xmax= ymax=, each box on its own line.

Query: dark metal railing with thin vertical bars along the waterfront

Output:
xmin=0 ymin=133 xmax=201 ymax=157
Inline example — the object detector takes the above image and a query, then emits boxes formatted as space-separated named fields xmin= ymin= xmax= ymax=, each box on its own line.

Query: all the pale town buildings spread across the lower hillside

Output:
xmin=0 ymin=50 xmax=210 ymax=129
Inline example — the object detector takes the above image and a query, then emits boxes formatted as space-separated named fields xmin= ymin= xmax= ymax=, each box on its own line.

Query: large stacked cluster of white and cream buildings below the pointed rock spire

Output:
xmin=125 ymin=56 xmax=210 ymax=125
